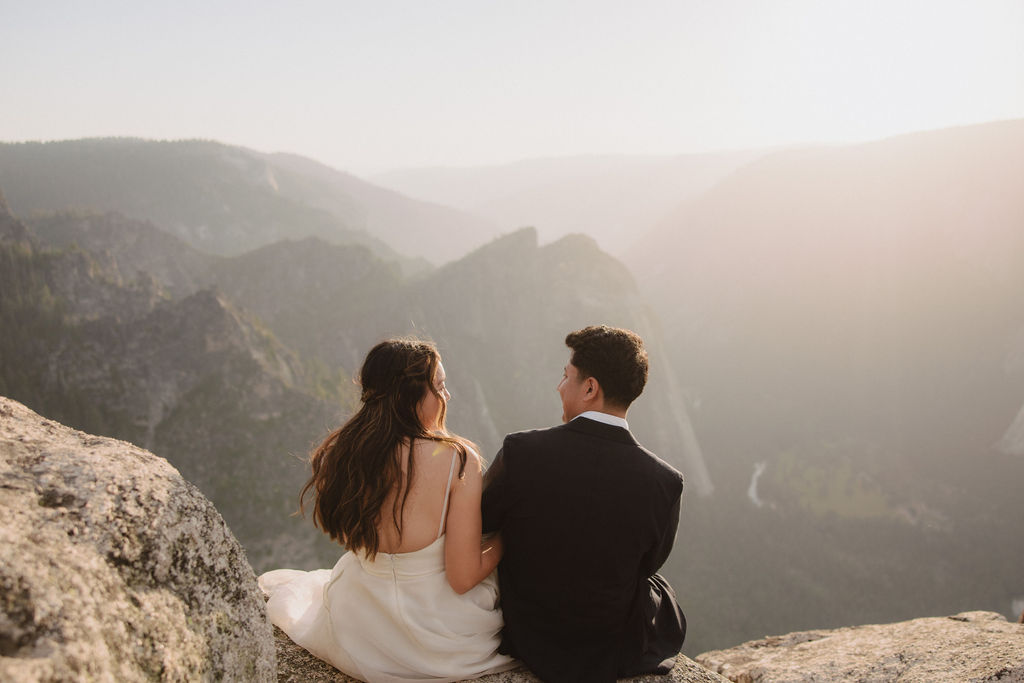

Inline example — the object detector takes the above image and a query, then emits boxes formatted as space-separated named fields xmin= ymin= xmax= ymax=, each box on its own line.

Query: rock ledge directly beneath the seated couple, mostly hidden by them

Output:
xmin=273 ymin=628 xmax=727 ymax=683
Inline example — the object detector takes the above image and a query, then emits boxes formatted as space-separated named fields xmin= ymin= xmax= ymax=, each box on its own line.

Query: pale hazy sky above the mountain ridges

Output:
xmin=0 ymin=0 xmax=1024 ymax=173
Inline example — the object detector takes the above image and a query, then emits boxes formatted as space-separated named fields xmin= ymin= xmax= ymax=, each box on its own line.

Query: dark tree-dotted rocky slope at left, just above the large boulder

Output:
xmin=0 ymin=208 xmax=350 ymax=565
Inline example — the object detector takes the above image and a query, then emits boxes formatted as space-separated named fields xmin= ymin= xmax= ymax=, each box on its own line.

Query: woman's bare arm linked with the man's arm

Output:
xmin=444 ymin=451 xmax=503 ymax=594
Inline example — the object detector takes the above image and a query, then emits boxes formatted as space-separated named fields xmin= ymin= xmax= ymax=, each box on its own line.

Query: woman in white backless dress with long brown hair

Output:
xmin=259 ymin=340 xmax=517 ymax=683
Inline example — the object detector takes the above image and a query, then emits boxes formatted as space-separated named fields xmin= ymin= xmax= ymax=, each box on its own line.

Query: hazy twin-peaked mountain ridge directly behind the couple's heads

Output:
xmin=206 ymin=228 xmax=713 ymax=495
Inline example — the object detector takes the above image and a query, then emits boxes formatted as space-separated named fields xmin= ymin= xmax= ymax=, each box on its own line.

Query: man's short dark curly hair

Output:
xmin=565 ymin=325 xmax=647 ymax=408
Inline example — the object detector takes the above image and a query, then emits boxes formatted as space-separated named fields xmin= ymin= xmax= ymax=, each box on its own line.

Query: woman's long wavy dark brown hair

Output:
xmin=299 ymin=339 xmax=468 ymax=559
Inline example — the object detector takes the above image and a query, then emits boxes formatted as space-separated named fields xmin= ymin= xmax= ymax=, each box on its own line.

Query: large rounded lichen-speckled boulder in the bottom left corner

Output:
xmin=0 ymin=397 xmax=274 ymax=682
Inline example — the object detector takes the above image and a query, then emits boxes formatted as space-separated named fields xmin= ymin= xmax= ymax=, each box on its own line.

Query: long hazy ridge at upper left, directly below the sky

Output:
xmin=0 ymin=138 xmax=494 ymax=271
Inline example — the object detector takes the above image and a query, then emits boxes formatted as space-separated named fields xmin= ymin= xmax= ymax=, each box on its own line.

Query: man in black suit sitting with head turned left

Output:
xmin=482 ymin=326 xmax=686 ymax=682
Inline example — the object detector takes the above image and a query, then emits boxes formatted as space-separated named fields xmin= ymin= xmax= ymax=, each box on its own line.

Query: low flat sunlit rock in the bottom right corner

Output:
xmin=697 ymin=611 xmax=1024 ymax=683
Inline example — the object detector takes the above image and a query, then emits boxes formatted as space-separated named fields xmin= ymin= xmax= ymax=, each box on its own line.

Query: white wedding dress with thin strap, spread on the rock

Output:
xmin=259 ymin=456 xmax=518 ymax=683
